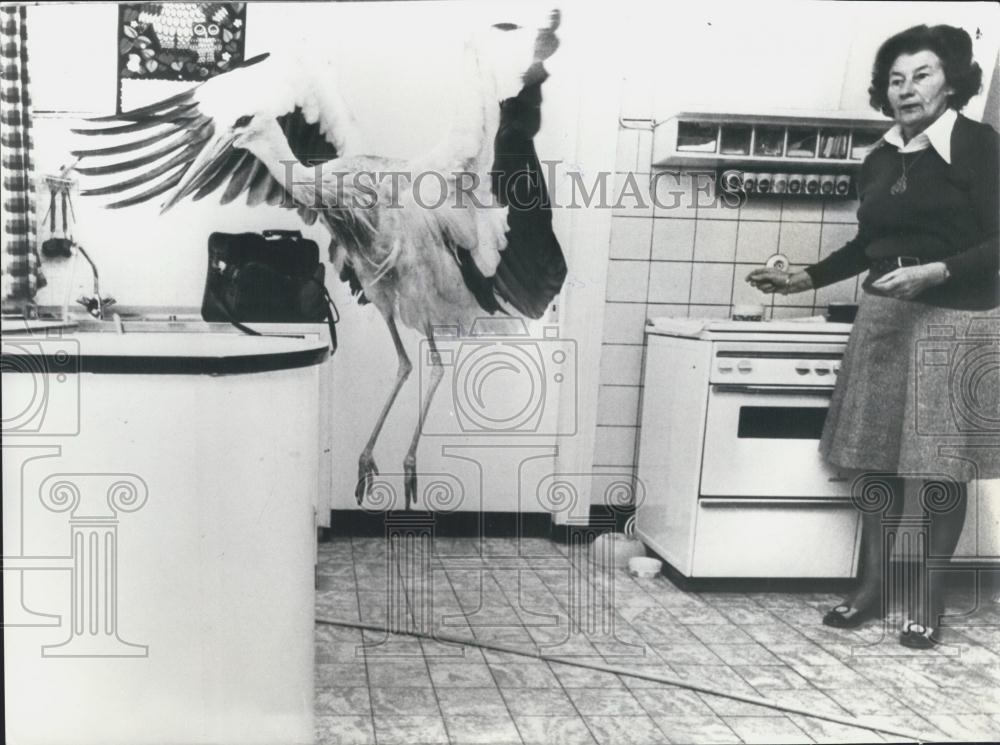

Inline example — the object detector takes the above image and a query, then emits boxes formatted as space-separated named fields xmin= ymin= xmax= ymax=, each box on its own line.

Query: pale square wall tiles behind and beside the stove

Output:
xmin=594 ymin=126 xmax=858 ymax=472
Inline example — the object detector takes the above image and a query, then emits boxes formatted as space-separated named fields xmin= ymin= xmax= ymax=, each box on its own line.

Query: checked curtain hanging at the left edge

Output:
xmin=0 ymin=5 xmax=45 ymax=305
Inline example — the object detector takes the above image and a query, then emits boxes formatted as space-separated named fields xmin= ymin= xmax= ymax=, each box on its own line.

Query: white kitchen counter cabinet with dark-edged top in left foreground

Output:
xmin=2 ymin=328 xmax=326 ymax=745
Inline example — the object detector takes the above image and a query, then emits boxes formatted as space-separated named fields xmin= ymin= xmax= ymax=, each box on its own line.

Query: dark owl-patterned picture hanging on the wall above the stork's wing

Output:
xmin=117 ymin=3 xmax=246 ymax=112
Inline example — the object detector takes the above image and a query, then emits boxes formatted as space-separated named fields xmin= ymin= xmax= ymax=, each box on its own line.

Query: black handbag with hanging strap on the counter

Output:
xmin=201 ymin=230 xmax=340 ymax=351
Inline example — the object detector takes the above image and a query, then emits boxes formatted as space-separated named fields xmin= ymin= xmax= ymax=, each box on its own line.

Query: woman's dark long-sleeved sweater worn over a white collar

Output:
xmin=805 ymin=115 xmax=1000 ymax=310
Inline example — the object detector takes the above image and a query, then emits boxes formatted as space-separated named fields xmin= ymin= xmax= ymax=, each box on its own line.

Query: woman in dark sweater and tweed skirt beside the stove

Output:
xmin=747 ymin=26 xmax=1000 ymax=648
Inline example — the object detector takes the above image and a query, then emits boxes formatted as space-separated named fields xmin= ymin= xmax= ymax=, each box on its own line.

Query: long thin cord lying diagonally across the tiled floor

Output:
xmin=316 ymin=618 xmax=925 ymax=742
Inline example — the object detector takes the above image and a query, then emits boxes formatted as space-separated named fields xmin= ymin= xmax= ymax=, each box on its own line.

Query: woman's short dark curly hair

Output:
xmin=868 ymin=25 xmax=983 ymax=116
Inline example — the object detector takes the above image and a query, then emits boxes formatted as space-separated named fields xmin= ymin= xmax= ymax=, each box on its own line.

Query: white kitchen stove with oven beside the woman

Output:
xmin=637 ymin=318 xmax=860 ymax=577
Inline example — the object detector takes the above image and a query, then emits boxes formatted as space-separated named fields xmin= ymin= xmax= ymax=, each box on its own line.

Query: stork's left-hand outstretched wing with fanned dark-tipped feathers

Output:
xmin=73 ymin=55 xmax=338 ymax=212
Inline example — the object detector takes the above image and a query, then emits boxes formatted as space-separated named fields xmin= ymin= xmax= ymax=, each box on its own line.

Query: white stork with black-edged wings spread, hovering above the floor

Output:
xmin=74 ymin=11 xmax=566 ymax=509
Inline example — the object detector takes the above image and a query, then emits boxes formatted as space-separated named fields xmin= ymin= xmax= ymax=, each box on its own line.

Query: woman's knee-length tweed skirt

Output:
xmin=820 ymin=292 xmax=1000 ymax=482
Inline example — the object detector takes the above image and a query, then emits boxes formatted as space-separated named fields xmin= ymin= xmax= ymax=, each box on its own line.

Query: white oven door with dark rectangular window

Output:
xmin=700 ymin=385 xmax=851 ymax=499
